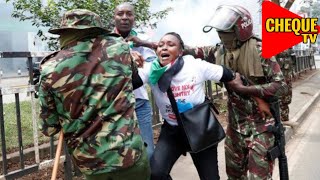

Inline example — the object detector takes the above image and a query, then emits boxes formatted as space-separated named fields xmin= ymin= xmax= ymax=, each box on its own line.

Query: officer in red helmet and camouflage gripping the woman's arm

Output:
xmin=185 ymin=5 xmax=287 ymax=180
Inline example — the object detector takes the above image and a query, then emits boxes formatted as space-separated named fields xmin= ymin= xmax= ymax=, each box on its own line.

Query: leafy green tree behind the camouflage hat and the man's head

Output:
xmin=6 ymin=0 xmax=171 ymax=50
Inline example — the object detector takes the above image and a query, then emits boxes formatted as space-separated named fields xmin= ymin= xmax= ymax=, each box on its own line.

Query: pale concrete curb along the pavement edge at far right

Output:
xmin=285 ymin=90 xmax=320 ymax=142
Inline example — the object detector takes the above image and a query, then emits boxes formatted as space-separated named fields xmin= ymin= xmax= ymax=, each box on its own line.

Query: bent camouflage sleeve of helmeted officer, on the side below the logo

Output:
xmin=255 ymin=57 xmax=288 ymax=98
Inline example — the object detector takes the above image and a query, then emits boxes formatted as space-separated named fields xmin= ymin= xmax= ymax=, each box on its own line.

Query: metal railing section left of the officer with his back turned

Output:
xmin=0 ymin=52 xmax=72 ymax=179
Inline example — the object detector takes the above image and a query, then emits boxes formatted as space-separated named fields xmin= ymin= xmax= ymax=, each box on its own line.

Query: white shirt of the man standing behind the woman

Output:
xmin=132 ymin=46 xmax=157 ymax=100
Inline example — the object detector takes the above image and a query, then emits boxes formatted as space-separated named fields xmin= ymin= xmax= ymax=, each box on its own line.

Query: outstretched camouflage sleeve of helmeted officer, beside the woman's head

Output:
xmin=183 ymin=46 xmax=217 ymax=63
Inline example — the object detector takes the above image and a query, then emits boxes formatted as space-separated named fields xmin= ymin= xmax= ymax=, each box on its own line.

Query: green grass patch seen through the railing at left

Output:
xmin=0 ymin=100 xmax=50 ymax=153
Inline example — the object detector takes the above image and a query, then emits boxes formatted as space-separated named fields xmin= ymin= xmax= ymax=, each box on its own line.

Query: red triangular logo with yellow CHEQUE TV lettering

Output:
xmin=262 ymin=1 xmax=320 ymax=58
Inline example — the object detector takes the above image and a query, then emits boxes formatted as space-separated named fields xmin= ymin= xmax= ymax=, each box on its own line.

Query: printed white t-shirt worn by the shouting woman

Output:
xmin=139 ymin=55 xmax=223 ymax=125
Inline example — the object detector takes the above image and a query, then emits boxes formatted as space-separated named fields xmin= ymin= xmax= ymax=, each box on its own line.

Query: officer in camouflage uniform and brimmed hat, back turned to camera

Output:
xmin=39 ymin=9 xmax=150 ymax=180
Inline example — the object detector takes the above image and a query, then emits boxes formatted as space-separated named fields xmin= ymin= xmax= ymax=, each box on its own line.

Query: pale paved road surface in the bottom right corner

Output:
xmin=287 ymin=101 xmax=320 ymax=180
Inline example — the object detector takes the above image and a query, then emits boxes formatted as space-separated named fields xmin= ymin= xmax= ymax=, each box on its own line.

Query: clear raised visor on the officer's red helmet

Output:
xmin=203 ymin=7 xmax=240 ymax=32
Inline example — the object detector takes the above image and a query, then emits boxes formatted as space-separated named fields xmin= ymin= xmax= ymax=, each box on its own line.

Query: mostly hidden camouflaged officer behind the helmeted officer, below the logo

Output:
xmin=276 ymin=48 xmax=294 ymax=121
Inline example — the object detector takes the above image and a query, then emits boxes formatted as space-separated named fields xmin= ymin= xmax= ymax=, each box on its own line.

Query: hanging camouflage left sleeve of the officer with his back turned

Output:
xmin=39 ymin=76 xmax=61 ymax=136
